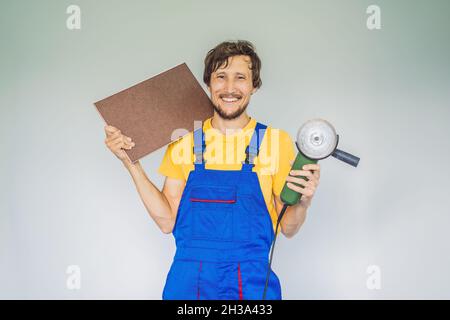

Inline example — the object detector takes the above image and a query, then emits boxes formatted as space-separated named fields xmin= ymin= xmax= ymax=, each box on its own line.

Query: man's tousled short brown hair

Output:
xmin=203 ymin=40 xmax=262 ymax=88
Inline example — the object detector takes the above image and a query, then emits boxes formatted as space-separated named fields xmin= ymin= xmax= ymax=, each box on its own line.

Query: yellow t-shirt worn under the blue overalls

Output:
xmin=158 ymin=118 xmax=295 ymax=230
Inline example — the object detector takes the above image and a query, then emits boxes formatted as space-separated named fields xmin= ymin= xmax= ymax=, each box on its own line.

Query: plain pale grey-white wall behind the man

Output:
xmin=0 ymin=0 xmax=450 ymax=299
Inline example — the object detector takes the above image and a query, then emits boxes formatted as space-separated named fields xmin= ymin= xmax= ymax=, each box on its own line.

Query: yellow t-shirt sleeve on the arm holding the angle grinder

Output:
xmin=272 ymin=130 xmax=296 ymax=196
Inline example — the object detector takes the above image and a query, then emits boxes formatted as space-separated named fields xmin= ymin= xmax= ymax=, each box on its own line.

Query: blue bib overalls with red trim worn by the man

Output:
xmin=163 ymin=123 xmax=281 ymax=300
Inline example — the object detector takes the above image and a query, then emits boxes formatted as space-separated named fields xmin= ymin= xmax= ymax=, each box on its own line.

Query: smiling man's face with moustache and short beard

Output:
xmin=208 ymin=55 xmax=256 ymax=120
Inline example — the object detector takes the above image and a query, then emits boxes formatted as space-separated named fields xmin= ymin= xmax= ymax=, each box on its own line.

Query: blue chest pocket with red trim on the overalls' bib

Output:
xmin=189 ymin=186 xmax=236 ymax=241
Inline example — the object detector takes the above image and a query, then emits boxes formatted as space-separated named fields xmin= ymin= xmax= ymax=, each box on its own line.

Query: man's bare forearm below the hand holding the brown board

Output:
xmin=124 ymin=162 xmax=174 ymax=233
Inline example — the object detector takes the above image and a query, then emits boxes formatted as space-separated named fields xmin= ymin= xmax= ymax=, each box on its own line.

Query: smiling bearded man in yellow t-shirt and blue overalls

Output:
xmin=106 ymin=41 xmax=320 ymax=300
